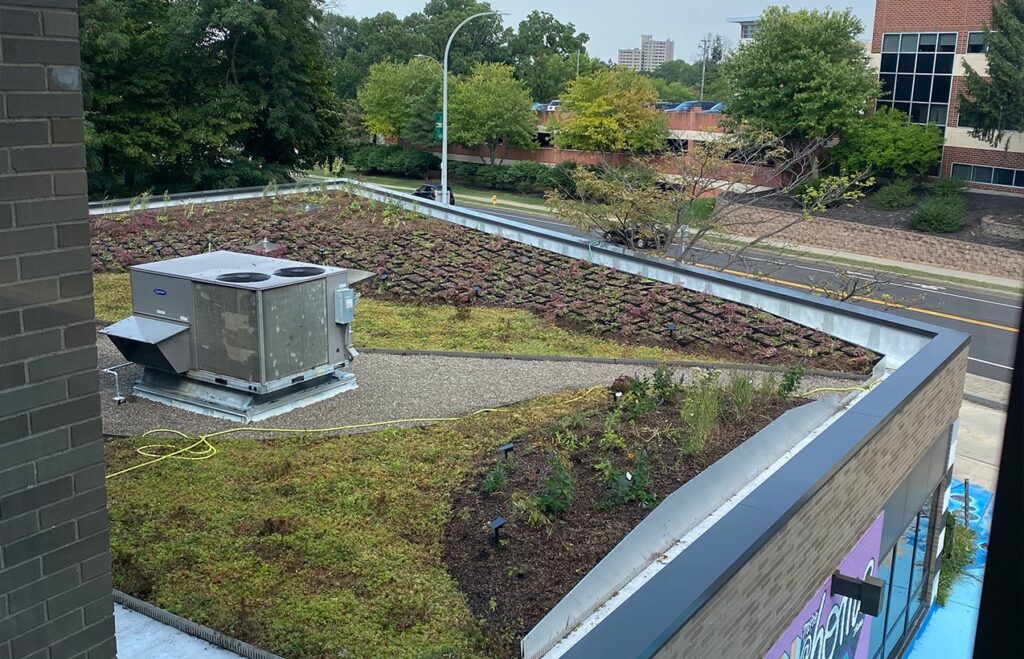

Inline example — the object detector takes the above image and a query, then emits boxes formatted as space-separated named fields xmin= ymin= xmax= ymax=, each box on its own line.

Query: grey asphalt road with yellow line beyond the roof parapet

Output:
xmin=461 ymin=199 xmax=1021 ymax=382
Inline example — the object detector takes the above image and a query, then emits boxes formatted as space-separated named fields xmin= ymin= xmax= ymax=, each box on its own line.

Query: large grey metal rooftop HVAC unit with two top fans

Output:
xmin=102 ymin=252 xmax=370 ymax=422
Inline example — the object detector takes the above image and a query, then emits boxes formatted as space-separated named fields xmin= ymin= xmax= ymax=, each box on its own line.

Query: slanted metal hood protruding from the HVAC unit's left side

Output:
xmin=100 ymin=316 xmax=191 ymax=374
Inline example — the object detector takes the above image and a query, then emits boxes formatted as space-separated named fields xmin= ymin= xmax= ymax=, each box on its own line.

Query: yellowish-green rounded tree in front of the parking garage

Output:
xmin=551 ymin=67 xmax=668 ymax=152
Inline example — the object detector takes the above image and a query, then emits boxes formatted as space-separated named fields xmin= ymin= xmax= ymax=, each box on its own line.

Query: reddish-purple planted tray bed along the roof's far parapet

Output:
xmin=92 ymin=194 xmax=879 ymax=374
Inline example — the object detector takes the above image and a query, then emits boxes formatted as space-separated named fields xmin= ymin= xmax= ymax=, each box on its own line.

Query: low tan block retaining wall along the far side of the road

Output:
xmin=723 ymin=207 xmax=1024 ymax=279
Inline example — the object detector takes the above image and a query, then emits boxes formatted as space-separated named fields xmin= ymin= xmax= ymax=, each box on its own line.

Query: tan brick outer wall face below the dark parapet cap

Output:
xmin=658 ymin=349 xmax=967 ymax=659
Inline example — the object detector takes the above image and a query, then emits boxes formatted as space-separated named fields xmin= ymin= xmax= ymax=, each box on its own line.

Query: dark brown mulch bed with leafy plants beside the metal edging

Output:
xmin=442 ymin=376 xmax=807 ymax=657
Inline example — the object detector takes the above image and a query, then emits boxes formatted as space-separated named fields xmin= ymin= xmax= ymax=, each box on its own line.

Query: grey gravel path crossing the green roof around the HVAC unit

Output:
xmin=97 ymin=335 xmax=858 ymax=437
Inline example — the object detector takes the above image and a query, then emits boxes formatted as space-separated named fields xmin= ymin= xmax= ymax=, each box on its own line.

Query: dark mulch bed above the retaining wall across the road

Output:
xmin=760 ymin=189 xmax=1024 ymax=251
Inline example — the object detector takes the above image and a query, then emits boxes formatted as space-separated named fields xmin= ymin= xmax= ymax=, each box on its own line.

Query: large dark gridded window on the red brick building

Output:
xmin=878 ymin=32 xmax=956 ymax=126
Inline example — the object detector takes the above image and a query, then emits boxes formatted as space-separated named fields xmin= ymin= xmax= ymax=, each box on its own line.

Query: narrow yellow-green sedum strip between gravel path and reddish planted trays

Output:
xmin=94 ymin=273 xmax=693 ymax=360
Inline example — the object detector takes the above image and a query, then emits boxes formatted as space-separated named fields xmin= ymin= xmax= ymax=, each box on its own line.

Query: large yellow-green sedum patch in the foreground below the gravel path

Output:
xmin=105 ymin=394 xmax=589 ymax=657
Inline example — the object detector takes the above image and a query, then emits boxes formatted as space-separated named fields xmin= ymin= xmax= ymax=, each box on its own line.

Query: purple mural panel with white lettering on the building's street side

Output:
xmin=765 ymin=513 xmax=885 ymax=659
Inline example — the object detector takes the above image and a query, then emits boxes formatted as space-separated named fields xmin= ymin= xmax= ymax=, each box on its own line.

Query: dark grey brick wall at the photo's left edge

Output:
xmin=0 ymin=0 xmax=116 ymax=659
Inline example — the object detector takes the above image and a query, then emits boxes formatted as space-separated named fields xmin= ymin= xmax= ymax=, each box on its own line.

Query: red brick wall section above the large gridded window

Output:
xmin=871 ymin=0 xmax=992 ymax=53
